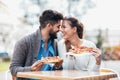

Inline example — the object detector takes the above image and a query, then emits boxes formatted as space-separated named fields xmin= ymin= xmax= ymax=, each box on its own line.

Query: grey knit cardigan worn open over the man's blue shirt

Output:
xmin=10 ymin=30 xmax=58 ymax=80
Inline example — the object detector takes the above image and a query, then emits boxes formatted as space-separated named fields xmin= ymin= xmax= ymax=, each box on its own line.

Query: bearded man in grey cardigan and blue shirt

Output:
xmin=10 ymin=10 xmax=63 ymax=80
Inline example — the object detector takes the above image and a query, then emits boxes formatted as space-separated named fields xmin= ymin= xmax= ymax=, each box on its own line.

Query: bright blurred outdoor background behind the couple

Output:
xmin=0 ymin=0 xmax=120 ymax=79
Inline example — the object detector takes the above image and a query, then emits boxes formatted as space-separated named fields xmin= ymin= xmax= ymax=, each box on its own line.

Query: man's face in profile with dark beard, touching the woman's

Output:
xmin=49 ymin=21 xmax=60 ymax=39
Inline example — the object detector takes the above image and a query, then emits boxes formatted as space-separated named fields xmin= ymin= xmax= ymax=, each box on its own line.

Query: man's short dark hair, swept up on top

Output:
xmin=39 ymin=10 xmax=63 ymax=28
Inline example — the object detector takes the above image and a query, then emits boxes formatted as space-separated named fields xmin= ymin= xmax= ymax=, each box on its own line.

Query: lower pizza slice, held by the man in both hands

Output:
xmin=42 ymin=56 xmax=63 ymax=63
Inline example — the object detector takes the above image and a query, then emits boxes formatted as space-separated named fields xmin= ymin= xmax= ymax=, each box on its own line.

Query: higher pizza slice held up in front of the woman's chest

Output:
xmin=70 ymin=46 xmax=96 ymax=54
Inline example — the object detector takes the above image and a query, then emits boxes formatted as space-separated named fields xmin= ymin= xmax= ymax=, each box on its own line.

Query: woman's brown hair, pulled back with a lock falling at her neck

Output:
xmin=63 ymin=17 xmax=84 ymax=52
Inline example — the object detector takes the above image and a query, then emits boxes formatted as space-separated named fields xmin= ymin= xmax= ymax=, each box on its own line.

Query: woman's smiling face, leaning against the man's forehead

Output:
xmin=61 ymin=20 xmax=76 ymax=40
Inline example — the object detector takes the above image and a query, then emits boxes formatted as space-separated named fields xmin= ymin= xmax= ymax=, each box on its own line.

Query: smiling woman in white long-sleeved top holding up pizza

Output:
xmin=58 ymin=17 xmax=101 ymax=71
